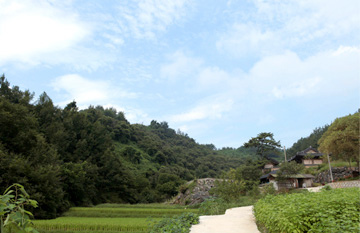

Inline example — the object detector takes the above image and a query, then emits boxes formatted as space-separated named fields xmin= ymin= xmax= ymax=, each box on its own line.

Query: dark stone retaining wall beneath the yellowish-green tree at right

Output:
xmin=314 ymin=167 xmax=359 ymax=183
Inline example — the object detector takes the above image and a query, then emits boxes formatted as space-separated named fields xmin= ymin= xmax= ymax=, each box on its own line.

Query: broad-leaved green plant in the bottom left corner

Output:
xmin=0 ymin=184 xmax=38 ymax=233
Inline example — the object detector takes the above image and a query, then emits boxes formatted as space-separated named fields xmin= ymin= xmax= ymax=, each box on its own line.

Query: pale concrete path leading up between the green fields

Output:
xmin=190 ymin=206 xmax=260 ymax=233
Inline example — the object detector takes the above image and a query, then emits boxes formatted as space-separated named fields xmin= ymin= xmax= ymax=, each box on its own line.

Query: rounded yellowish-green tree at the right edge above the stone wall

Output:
xmin=319 ymin=112 xmax=360 ymax=169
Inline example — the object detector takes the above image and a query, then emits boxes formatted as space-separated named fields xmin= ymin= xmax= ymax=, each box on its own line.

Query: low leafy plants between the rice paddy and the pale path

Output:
xmin=150 ymin=213 xmax=199 ymax=233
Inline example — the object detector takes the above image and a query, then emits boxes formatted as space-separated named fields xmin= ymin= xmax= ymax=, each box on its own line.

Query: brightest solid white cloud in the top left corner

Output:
xmin=0 ymin=0 xmax=90 ymax=64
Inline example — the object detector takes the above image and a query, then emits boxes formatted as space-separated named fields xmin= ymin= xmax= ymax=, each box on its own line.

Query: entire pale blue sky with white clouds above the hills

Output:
xmin=0 ymin=0 xmax=360 ymax=149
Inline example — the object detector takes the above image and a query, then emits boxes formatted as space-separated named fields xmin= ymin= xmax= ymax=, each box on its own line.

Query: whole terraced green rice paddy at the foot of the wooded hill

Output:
xmin=33 ymin=204 xmax=198 ymax=233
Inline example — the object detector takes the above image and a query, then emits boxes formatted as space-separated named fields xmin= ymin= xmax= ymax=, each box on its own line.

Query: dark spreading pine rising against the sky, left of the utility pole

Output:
xmin=244 ymin=133 xmax=281 ymax=158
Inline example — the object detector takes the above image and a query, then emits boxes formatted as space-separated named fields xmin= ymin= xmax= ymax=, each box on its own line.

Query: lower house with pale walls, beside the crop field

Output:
xmin=267 ymin=173 xmax=315 ymax=190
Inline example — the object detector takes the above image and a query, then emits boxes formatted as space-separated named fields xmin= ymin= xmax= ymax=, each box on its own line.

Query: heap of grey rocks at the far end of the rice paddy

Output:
xmin=173 ymin=178 xmax=219 ymax=205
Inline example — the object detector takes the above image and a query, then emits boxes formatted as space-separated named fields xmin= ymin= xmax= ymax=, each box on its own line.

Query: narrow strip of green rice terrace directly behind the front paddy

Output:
xmin=64 ymin=207 xmax=198 ymax=218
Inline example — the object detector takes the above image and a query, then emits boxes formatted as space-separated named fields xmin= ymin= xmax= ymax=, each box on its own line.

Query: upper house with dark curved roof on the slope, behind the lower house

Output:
xmin=288 ymin=146 xmax=323 ymax=168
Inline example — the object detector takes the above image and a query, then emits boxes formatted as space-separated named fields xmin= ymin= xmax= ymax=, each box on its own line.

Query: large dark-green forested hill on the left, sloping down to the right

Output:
xmin=0 ymin=76 xmax=242 ymax=218
